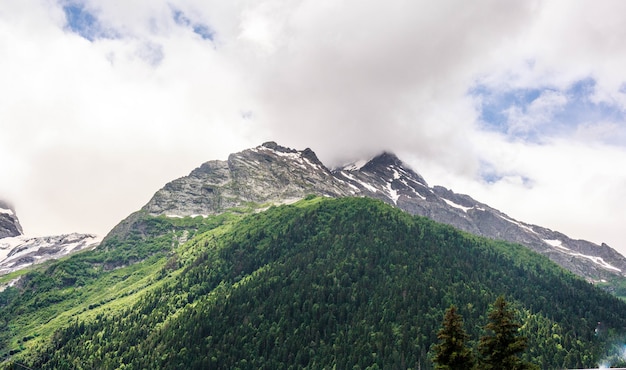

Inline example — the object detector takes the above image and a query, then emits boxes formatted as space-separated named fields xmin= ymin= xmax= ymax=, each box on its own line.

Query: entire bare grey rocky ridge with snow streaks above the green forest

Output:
xmin=132 ymin=142 xmax=626 ymax=281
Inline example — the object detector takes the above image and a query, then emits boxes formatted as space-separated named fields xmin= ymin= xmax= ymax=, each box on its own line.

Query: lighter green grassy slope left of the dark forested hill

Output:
xmin=0 ymin=214 xmax=240 ymax=358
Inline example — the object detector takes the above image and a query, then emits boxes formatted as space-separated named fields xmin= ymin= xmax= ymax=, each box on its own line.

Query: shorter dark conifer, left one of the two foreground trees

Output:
xmin=433 ymin=305 xmax=474 ymax=370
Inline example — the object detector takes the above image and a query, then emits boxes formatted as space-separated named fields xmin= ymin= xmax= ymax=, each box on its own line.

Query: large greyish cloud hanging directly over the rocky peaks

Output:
xmin=234 ymin=2 xmax=530 ymax=165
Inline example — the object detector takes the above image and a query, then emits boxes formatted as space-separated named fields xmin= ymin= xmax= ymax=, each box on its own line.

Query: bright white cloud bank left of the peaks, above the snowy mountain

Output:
xmin=0 ymin=3 xmax=256 ymax=234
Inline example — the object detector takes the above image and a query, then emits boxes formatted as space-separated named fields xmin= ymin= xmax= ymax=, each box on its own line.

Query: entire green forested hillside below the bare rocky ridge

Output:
xmin=0 ymin=198 xmax=626 ymax=369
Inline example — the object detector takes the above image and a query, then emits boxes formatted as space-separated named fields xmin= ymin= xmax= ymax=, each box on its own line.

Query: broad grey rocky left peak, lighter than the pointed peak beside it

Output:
xmin=143 ymin=143 xmax=352 ymax=216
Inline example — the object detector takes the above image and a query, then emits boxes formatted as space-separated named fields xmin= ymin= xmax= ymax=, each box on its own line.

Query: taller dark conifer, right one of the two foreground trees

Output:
xmin=478 ymin=296 xmax=535 ymax=370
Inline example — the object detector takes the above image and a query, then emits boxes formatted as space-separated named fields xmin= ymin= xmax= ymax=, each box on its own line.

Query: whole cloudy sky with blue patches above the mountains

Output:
xmin=0 ymin=0 xmax=626 ymax=253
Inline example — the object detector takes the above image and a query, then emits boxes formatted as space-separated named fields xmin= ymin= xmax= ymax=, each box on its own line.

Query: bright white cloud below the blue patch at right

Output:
xmin=476 ymin=138 xmax=626 ymax=251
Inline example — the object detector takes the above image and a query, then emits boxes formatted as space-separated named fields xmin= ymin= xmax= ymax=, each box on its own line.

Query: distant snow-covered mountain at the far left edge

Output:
xmin=0 ymin=201 xmax=102 ymax=276
